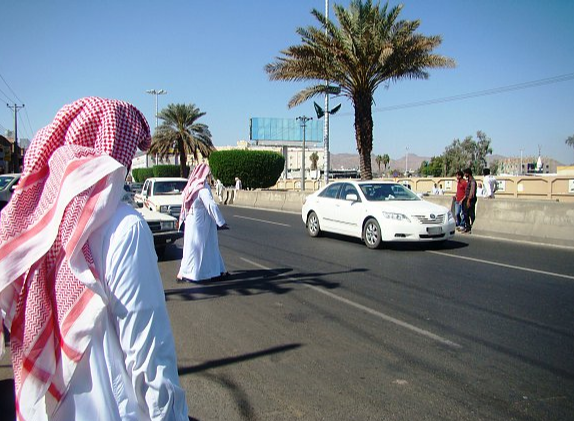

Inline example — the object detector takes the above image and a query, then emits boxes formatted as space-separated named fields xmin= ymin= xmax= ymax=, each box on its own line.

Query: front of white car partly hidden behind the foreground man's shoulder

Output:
xmin=122 ymin=192 xmax=183 ymax=256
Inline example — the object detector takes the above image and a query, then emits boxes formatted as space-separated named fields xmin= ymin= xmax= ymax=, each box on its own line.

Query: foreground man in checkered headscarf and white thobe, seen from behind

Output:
xmin=0 ymin=97 xmax=188 ymax=421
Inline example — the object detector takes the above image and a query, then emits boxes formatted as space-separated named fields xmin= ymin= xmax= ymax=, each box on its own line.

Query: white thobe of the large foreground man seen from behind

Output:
xmin=30 ymin=203 xmax=188 ymax=421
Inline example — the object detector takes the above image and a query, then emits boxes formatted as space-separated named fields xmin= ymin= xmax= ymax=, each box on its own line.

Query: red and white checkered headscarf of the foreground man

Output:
xmin=0 ymin=97 xmax=151 ymax=420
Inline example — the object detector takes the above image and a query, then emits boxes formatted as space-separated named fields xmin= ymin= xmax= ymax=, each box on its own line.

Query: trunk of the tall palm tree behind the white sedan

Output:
xmin=353 ymin=94 xmax=373 ymax=180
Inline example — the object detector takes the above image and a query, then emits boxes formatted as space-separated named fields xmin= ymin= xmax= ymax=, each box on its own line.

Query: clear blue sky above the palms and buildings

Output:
xmin=0 ymin=0 xmax=574 ymax=164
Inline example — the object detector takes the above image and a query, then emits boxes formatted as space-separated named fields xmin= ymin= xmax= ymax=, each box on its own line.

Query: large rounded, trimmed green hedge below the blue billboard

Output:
xmin=209 ymin=149 xmax=285 ymax=189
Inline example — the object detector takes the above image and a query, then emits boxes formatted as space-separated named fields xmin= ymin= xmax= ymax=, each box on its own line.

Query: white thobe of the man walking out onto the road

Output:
xmin=179 ymin=187 xmax=225 ymax=281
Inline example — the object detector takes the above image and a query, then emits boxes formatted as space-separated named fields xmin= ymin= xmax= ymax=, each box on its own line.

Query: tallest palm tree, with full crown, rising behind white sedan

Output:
xmin=265 ymin=0 xmax=455 ymax=179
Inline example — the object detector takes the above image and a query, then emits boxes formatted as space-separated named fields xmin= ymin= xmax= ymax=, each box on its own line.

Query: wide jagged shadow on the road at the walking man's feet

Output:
xmin=165 ymin=268 xmax=366 ymax=301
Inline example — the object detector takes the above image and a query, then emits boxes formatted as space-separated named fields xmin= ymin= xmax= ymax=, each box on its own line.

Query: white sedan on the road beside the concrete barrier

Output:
xmin=301 ymin=181 xmax=455 ymax=248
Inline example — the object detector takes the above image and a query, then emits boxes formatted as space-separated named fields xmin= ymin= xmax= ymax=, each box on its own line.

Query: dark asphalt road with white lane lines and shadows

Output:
xmin=0 ymin=207 xmax=574 ymax=421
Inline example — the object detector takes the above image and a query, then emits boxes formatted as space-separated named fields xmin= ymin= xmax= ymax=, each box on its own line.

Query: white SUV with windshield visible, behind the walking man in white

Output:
xmin=134 ymin=177 xmax=187 ymax=218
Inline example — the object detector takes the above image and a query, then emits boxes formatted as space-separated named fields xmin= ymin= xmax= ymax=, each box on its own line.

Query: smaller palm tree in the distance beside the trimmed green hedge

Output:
xmin=149 ymin=104 xmax=215 ymax=177
